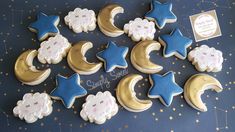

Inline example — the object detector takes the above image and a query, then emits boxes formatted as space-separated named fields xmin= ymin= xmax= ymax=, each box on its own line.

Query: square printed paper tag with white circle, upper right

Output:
xmin=189 ymin=10 xmax=222 ymax=42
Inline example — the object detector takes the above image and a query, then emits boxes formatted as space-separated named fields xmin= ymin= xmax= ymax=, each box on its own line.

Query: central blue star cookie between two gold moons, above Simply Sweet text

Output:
xmin=96 ymin=41 xmax=128 ymax=72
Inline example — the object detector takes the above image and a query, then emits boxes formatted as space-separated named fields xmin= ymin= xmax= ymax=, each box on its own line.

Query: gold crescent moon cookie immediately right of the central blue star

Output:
xmin=131 ymin=40 xmax=163 ymax=74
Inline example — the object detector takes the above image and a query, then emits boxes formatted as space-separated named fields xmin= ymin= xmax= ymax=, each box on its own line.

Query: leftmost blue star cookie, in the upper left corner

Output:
xmin=28 ymin=12 xmax=60 ymax=41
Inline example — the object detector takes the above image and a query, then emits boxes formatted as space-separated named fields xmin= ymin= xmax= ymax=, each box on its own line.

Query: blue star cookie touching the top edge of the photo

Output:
xmin=145 ymin=0 xmax=177 ymax=29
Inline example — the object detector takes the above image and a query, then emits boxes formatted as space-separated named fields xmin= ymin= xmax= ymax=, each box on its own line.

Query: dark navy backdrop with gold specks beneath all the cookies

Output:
xmin=0 ymin=0 xmax=235 ymax=132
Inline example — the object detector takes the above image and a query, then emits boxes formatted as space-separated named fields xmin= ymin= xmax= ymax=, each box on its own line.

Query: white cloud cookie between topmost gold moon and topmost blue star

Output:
xmin=124 ymin=18 xmax=156 ymax=41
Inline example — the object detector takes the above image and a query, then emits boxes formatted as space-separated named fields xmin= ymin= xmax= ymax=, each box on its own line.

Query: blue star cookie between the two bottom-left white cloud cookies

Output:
xmin=51 ymin=73 xmax=87 ymax=108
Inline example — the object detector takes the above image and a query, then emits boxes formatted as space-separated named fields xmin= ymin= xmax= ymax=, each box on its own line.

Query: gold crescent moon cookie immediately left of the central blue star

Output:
xmin=67 ymin=41 xmax=102 ymax=75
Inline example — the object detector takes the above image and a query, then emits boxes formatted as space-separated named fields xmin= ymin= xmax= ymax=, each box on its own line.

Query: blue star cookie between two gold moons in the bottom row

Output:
xmin=148 ymin=71 xmax=183 ymax=107
